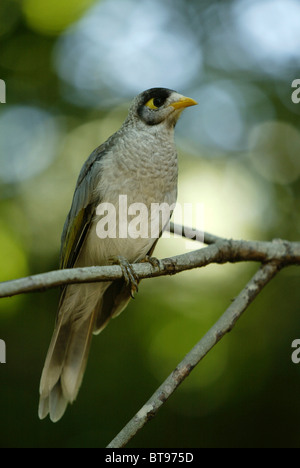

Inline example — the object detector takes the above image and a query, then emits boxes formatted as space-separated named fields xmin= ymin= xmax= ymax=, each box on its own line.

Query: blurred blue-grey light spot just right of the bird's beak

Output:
xmin=178 ymin=80 xmax=274 ymax=157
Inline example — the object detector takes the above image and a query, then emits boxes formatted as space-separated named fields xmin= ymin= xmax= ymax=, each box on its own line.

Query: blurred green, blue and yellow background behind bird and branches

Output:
xmin=0 ymin=0 xmax=300 ymax=448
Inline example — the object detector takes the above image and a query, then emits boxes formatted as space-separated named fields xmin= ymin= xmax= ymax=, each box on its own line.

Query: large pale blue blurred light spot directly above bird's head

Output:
xmin=55 ymin=0 xmax=202 ymax=105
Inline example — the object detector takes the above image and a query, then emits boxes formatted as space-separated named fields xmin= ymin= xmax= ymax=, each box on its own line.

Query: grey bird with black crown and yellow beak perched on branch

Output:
xmin=38 ymin=88 xmax=197 ymax=422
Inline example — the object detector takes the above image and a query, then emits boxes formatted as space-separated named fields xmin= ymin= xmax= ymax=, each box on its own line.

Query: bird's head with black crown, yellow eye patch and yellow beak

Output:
xmin=128 ymin=88 xmax=197 ymax=128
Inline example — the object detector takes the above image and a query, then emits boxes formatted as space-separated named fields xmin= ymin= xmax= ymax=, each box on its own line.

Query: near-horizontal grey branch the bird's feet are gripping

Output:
xmin=0 ymin=232 xmax=300 ymax=298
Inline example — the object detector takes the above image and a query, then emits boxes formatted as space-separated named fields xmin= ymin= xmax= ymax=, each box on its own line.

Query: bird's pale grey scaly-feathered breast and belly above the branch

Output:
xmin=81 ymin=134 xmax=177 ymax=264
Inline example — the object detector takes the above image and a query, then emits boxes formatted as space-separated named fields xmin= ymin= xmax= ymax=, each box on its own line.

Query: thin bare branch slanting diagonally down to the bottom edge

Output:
xmin=107 ymin=263 xmax=279 ymax=448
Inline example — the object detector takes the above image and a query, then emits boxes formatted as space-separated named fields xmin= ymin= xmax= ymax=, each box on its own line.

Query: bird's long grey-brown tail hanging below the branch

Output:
xmin=39 ymin=284 xmax=102 ymax=422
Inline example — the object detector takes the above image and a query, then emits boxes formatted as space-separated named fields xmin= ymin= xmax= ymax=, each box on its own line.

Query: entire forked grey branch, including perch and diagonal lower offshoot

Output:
xmin=0 ymin=224 xmax=300 ymax=448
